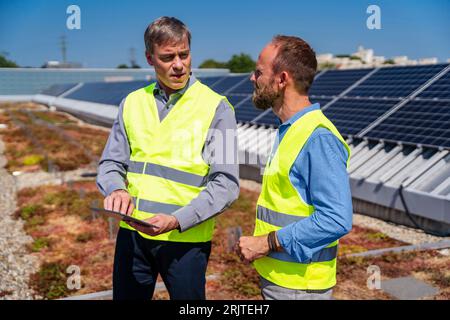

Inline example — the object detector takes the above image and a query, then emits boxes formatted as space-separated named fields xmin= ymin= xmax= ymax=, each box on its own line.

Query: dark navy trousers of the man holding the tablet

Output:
xmin=113 ymin=228 xmax=211 ymax=300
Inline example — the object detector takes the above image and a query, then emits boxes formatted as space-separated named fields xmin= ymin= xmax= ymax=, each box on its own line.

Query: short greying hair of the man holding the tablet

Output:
xmin=144 ymin=17 xmax=191 ymax=53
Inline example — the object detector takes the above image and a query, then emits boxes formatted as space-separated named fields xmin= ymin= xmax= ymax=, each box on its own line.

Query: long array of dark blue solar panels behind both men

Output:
xmin=39 ymin=64 xmax=450 ymax=148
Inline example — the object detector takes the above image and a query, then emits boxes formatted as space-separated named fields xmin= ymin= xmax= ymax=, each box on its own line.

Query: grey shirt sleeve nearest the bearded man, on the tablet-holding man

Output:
xmin=173 ymin=101 xmax=239 ymax=232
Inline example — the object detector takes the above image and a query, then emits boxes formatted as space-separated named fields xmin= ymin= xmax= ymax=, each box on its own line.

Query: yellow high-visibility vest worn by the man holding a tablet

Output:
xmin=120 ymin=81 xmax=231 ymax=242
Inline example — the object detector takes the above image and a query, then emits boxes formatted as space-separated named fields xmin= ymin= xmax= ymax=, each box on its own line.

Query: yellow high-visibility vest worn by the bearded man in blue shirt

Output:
xmin=253 ymin=110 xmax=350 ymax=290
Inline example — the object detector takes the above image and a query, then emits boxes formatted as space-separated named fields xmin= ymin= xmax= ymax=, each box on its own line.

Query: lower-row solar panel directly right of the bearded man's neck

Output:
xmin=324 ymin=98 xmax=398 ymax=135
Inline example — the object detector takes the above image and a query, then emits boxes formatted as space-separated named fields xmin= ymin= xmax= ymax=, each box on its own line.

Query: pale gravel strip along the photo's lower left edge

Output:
xmin=0 ymin=140 xmax=40 ymax=300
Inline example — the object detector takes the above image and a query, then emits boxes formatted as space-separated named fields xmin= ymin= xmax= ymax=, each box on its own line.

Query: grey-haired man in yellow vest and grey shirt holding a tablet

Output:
xmin=97 ymin=17 xmax=239 ymax=299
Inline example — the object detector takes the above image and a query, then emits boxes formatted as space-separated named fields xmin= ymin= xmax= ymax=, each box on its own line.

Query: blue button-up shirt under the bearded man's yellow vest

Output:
xmin=272 ymin=103 xmax=353 ymax=263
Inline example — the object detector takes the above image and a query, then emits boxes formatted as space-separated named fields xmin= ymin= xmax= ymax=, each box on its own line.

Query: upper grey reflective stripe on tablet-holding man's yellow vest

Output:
xmin=128 ymin=161 xmax=207 ymax=187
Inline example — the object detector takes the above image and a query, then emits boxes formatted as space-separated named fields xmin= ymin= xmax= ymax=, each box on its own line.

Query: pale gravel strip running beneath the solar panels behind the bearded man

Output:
xmin=240 ymin=179 xmax=450 ymax=244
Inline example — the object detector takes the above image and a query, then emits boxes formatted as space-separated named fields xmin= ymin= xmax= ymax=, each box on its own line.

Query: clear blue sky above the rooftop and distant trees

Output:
xmin=0 ymin=0 xmax=450 ymax=67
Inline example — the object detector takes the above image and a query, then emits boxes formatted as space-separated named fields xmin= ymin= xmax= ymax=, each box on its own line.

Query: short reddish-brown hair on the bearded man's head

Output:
xmin=272 ymin=35 xmax=317 ymax=94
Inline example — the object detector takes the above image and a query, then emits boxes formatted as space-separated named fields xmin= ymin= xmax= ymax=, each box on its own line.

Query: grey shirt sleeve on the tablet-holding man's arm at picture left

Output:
xmin=96 ymin=100 xmax=130 ymax=196
